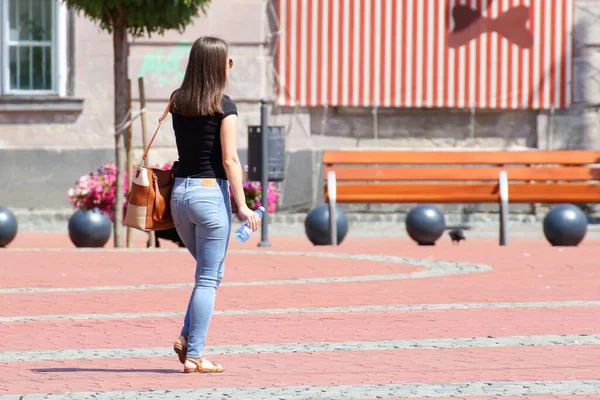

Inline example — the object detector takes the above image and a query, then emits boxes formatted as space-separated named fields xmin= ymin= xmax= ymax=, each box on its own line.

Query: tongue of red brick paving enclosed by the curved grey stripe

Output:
xmin=0 ymin=251 xmax=423 ymax=288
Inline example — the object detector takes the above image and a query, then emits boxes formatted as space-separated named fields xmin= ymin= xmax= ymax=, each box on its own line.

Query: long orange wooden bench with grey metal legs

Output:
xmin=323 ymin=150 xmax=600 ymax=245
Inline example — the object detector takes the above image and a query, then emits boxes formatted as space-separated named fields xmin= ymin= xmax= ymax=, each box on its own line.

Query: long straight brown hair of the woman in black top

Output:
xmin=173 ymin=36 xmax=229 ymax=116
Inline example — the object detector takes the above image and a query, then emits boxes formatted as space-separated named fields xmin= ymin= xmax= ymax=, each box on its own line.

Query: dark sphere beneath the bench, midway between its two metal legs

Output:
xmin=405 ymin=204 xmax=446 ymax=246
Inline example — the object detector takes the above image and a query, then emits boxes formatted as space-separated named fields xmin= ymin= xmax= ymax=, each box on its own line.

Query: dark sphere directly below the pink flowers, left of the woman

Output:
xmin=69 ymin=210 xmax=112 ymax=247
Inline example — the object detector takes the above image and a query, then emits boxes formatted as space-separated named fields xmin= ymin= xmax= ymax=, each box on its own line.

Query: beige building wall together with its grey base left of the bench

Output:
xmin=0 ymin=0 xmax=600 ymax=214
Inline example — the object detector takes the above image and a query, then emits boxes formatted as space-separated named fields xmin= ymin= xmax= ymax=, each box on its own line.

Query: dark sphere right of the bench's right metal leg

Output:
xmin=544 ymin=204 xmax=588 ymax=246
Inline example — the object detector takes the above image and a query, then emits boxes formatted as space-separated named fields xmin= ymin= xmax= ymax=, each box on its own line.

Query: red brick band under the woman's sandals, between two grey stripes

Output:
xmin=0 ymin=346 xmax=600 ymax=393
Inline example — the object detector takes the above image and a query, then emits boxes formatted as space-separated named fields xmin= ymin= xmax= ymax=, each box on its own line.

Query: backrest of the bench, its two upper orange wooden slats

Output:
xmin=323 ymin=150 xmax=600 ymax=181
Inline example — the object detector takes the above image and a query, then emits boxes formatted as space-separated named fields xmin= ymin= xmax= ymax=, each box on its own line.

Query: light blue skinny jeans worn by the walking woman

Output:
xmin=171 ymin=178 xmax=231 ymax=358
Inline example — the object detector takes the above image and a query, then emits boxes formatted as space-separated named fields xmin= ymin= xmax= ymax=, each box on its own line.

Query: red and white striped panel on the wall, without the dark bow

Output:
xmin=276 ymin=0 xmax=573 ymax=109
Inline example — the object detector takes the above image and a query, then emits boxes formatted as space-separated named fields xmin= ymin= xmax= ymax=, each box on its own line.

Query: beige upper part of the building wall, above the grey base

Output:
xmin=0 ymin=0 xmax=600 ymax=149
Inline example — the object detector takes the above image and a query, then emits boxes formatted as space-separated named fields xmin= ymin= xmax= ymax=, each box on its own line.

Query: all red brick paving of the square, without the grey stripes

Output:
xmin=0 ymin=234 xmax=600 ymax=400
